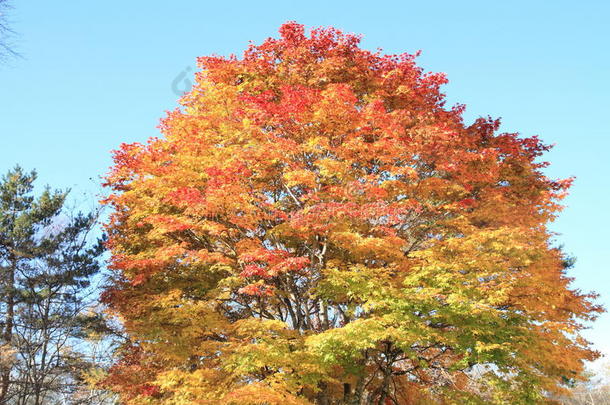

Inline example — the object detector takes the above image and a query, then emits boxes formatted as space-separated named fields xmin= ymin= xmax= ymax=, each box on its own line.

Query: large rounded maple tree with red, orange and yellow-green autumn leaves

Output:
xmin=103 ymin=23 xmax=601 ymax=404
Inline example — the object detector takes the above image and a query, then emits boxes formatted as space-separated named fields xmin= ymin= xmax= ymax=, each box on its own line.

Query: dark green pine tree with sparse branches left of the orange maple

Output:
xmin=0 ymin=167 xmax=103 ymax=405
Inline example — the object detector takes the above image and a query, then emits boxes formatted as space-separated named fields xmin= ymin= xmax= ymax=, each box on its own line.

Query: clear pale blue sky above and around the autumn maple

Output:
xmin=0 ymin=0 xmax=610 ymax=362
